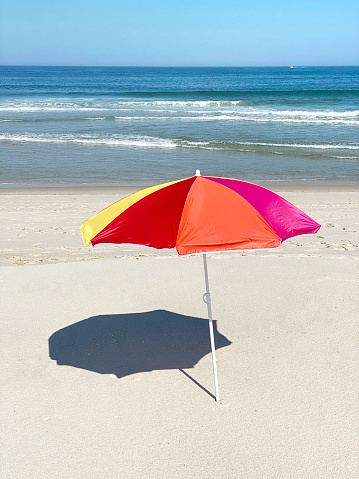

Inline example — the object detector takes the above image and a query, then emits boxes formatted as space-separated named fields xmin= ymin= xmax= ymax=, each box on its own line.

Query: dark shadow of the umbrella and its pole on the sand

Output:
xmin=49 ymin=310 xmax=231 ymax=396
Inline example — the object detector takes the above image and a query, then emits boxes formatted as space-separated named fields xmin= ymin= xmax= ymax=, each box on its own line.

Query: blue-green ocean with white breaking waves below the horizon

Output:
xmin=0 ymin=66 xmax=359 ymax=187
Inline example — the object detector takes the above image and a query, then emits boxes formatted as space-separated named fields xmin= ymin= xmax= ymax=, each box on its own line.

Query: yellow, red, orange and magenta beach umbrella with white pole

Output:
xmin=80 ymin=170 xmax=320 ymax=402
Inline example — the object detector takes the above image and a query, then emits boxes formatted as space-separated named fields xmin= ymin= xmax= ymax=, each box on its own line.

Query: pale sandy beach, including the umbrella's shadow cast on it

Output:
xmin=0 ymin=187 xmax=359 ymax=479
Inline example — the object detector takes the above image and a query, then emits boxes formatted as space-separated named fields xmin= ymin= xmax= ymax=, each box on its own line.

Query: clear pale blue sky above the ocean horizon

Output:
xmin=0 ymin=0 xmax=359 ymax=66
